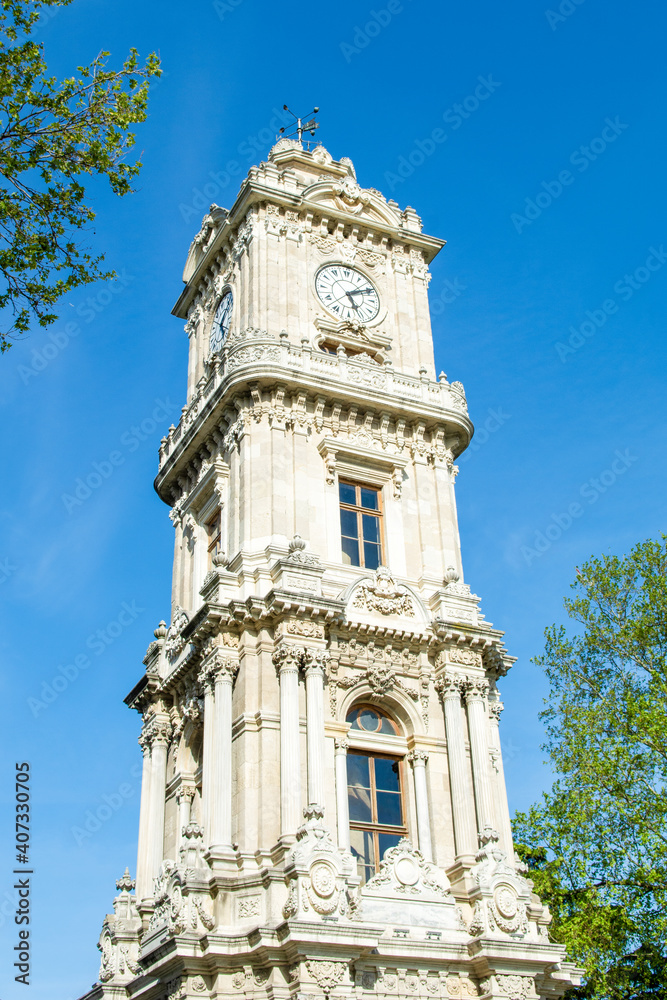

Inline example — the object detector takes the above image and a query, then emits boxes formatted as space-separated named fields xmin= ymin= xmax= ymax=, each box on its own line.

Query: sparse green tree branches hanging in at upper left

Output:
xmin=0 ymin=0 xmax=161 ymax=352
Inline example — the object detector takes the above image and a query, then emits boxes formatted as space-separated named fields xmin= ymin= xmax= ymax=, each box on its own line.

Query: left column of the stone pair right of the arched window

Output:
xmin=435 ymin=673 xmax=477 ymax=858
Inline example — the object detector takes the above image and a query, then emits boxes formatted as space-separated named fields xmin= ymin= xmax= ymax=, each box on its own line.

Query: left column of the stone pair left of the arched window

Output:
xmin=273 ymin=646 xmax=301 ymax=842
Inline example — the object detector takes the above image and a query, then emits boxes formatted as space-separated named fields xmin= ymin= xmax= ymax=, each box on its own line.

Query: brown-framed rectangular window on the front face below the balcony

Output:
xmin=338 ymin=482 xmax=383 ymax=569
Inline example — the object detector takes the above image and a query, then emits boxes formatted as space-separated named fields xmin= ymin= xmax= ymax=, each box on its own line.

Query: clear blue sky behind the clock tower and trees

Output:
xmin=0 ymin=0 xmax=667 ymax=1000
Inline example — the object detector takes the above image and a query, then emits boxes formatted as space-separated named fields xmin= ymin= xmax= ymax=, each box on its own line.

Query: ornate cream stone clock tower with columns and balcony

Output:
xmin=78 ymin=139 xmax=578 ymax=1000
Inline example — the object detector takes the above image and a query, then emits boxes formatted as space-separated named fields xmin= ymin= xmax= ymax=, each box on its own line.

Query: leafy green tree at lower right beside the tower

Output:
xmin=514 ymin=535 xmax=667 ymax=1000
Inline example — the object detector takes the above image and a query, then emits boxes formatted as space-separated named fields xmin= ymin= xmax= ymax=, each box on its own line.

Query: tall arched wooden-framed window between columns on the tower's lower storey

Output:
xmin=346 ymin=705 xmax=407 ymax=882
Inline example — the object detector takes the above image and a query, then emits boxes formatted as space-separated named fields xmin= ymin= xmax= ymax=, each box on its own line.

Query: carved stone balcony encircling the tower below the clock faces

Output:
xmin=155 ymin=328 xmax=473 ymax=502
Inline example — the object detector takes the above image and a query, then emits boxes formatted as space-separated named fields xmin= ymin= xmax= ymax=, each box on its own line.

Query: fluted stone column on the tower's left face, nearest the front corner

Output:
xmin=208 ymin=659 xmax=239 ymax=857
